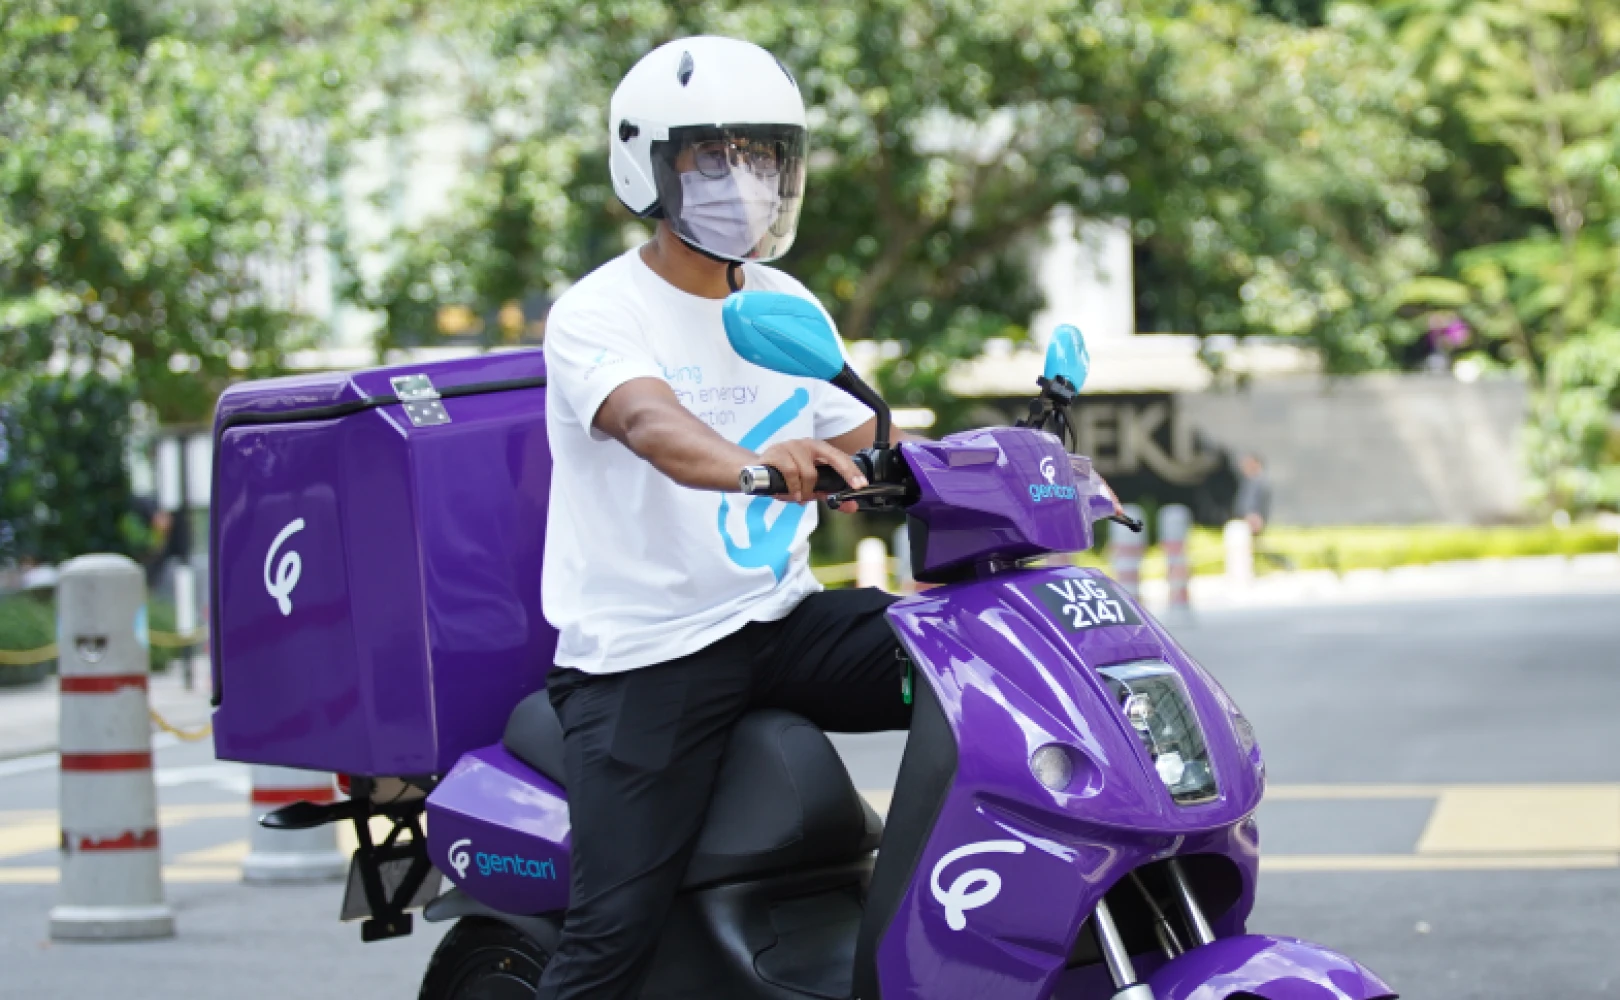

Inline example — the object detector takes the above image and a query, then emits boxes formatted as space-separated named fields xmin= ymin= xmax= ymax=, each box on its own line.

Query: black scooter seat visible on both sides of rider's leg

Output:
xmin=501 ymin=690 xmax=883 ymax=888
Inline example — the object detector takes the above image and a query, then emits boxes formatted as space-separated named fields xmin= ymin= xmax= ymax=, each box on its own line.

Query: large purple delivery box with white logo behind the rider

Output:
xmin=209 ymin=350 xmax=557 ymax=776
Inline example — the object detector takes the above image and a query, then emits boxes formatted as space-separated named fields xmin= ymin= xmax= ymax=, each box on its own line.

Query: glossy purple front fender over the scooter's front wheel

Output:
xmin=1149 ymin=934 xmax=1395 ymax=1000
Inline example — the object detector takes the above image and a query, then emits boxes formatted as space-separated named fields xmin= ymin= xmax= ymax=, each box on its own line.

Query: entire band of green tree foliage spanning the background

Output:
xmin=12 ymin=0 xmax=1620 ymax=538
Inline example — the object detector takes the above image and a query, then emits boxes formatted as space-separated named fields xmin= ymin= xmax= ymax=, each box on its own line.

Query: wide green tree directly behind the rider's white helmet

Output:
xmin=360 ymin=0 xmax=1437 ymax=408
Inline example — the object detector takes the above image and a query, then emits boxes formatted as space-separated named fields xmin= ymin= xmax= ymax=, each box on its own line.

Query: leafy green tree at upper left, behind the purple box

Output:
xmin=0 ymin=0 xmax=374 ymax=421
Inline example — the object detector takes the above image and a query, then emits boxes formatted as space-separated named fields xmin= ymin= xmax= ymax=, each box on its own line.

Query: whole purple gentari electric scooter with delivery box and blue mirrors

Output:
xmin=202 ymin=292 xmax=1395 ymax=1000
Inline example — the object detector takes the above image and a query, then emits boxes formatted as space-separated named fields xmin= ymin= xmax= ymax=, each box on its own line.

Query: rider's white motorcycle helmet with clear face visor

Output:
xmin=608 ymin=36 xmax=807 ymax=261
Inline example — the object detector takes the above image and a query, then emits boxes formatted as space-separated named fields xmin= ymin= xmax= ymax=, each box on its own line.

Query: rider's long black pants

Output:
xmin=539 ymin=590 xmax=910 ymax=1000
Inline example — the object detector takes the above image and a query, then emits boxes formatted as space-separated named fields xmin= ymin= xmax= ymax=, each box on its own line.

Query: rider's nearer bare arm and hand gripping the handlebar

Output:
xmin=593 ymin=378 xmax=865 ymax=502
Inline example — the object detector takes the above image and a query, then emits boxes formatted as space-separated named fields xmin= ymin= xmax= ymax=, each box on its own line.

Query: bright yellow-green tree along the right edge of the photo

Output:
xmin=1383 ymin=0 xmax=1620 ymax=506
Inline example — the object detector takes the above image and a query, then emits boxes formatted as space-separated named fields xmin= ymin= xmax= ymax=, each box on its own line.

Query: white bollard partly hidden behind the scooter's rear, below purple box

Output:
xmin=241 ymin=763 xmax=348 ymax=885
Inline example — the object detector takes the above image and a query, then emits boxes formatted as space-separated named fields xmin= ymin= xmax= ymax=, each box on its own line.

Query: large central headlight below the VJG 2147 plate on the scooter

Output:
xmin=1097 ymin=660 xmax=1217 ymax=806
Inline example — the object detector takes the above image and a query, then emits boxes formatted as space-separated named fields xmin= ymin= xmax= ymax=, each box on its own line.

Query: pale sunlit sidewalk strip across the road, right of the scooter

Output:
xmin=1142 ymin=553 xmax=1620 ymax=611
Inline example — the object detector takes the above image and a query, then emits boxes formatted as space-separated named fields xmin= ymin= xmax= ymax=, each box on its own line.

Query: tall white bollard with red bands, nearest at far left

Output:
xmin=50 ymin=554 xmax=175 ymax=940
